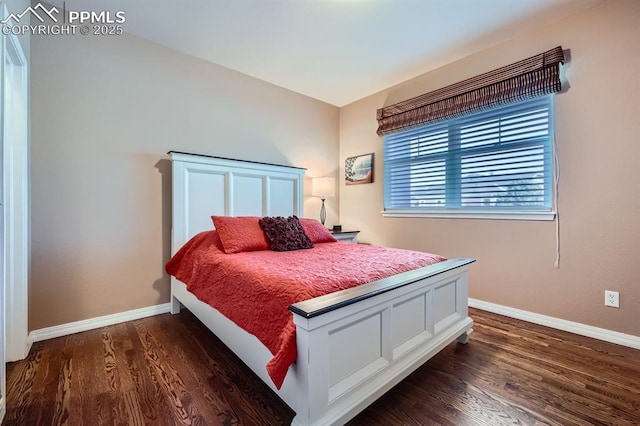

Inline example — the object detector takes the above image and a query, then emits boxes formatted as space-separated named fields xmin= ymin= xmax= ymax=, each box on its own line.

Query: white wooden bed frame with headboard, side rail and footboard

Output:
xmin=169 ymin=151 xmax=474 ymax=425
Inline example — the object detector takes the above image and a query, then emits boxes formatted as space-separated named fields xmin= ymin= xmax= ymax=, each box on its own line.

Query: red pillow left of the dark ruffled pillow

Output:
xmin=211 ymin=216 xmax=269 ymax=253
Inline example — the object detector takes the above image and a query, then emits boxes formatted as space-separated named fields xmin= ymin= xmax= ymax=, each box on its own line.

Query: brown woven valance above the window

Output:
xmin=377 ymin=46 xmax=564 ymax=135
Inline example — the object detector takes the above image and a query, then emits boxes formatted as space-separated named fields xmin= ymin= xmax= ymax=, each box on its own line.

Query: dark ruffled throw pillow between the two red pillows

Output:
xmin=259 ymin=216 xmax=313 ymax=251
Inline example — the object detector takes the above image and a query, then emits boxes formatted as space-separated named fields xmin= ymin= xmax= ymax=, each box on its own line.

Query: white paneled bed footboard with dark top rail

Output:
xmin=290 ymin=259 xmax=474 ymax=425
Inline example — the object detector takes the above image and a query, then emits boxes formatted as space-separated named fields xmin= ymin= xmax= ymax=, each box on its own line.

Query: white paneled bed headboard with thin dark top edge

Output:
xmin=169 ymin=151 xmax=306 ymax=254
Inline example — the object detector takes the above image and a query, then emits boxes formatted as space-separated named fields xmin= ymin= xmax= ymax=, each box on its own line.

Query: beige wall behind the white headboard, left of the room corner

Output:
xmin=29 ymin=31 xmax=339 ymax=330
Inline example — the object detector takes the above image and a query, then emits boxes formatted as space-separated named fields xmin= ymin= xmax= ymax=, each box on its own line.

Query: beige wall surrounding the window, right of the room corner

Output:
xmin=340 ymin=0 xmax=640 ymax=336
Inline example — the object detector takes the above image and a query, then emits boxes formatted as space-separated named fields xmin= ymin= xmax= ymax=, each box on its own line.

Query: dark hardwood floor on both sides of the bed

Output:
xmin=3 ymin=310 xmax=640 ymax=426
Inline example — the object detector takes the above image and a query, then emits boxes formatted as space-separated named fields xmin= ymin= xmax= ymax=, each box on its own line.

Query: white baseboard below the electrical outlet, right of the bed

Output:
xmin=469 ymin=298 xmax=640 ymax=349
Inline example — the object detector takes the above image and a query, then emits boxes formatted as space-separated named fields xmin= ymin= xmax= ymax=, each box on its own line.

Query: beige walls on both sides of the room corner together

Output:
xmin=28 ymin=0 xmax=640 ymax=335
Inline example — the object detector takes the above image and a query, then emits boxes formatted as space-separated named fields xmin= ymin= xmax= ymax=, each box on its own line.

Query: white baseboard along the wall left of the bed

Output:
xmin=29 ymin=303 xmax=171 ymax=342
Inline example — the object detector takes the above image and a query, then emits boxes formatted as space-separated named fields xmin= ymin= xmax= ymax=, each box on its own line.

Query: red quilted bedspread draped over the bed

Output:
xmin=166 ymin=231 xmax=445 ymax=388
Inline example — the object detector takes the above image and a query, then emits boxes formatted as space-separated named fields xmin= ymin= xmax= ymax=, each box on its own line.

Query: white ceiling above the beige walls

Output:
xmin=50 ymin=0 xmax=602 ymax=106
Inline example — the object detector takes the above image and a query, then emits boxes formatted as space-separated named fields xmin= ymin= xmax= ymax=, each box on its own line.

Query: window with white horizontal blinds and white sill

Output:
xmin=384 ymin=95 xmax=555 ymax=220
